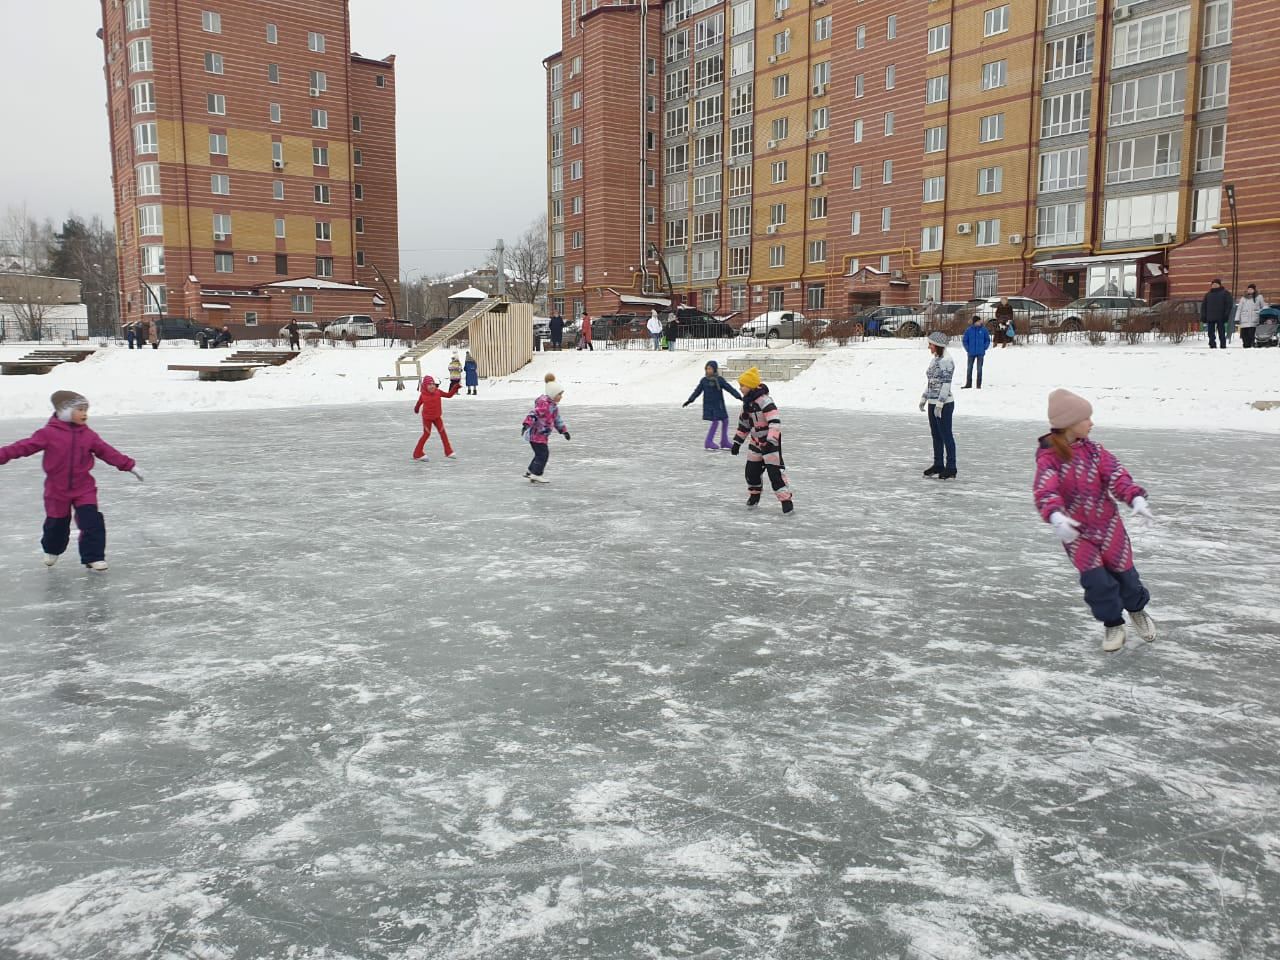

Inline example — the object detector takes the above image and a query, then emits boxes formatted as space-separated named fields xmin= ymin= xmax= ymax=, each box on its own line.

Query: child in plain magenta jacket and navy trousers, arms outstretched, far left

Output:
xmin=0 ymin=390 xmax=142 ymax=573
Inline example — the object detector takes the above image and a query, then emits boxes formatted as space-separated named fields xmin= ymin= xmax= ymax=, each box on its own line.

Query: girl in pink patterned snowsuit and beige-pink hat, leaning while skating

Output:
xmin=1034 ymin=390 xmax=1156 ymax=653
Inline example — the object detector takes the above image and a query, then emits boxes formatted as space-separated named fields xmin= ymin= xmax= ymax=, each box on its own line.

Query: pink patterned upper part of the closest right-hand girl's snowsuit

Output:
xmin=1033 ymin=435 xmax=1147 ymax=573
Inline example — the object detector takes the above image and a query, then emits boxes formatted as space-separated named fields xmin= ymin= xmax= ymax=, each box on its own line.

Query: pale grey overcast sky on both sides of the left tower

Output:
xmin=0 ymin=0 xmax=559 ymax=273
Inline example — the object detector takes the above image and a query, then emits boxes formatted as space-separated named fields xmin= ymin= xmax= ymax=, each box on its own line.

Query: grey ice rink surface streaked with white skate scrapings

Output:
xmin=0 ymin=407 xmax=1280 ymax=960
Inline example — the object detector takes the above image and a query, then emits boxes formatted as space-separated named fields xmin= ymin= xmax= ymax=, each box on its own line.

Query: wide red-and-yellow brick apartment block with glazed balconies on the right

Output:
xmin=545 ymin=0 xmax=1280 ymax=323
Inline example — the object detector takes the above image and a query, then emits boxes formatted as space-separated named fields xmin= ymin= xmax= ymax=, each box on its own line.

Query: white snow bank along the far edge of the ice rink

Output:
xmin=0 ymin=340 xmax=1280 ymax=433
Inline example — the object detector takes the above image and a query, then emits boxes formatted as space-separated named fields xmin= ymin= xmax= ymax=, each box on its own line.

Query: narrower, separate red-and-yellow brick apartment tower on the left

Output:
xmin=100 ymin=0 xmax=399 ymax=333
